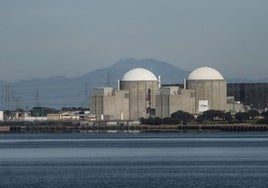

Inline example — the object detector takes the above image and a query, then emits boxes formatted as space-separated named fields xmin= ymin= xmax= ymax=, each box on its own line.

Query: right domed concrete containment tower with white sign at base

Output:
xmin=186 ymin=67 xmax=226 ymax=113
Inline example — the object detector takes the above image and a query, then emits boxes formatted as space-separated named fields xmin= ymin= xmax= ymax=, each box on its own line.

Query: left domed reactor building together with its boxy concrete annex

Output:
xmin=90 ymin=68 xmax=159 ymax=120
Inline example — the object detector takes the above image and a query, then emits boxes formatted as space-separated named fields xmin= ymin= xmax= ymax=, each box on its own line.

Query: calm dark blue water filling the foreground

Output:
xmin=0 ymin=132 xmax=268 ymax=188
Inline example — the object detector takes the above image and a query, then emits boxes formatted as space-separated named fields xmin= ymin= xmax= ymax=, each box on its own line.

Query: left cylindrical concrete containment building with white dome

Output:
xmin=119 ymin=68 xmax=160 ymax=120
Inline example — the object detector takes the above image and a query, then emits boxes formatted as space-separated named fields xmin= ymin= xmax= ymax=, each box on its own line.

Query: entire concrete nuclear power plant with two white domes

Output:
xmin=90 ymin=67 xmax=243 ymax=120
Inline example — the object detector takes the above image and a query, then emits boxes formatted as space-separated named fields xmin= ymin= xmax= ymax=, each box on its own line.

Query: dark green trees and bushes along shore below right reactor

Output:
xmin=140 ymin=110 xmax=268 ymax=125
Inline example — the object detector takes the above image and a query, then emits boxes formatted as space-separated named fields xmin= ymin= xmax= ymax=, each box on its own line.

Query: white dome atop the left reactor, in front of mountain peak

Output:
xmin=122 ymin=68 xmax=157 ymax=81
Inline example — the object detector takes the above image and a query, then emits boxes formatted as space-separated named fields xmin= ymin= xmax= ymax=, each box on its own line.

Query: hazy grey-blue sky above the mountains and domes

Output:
xmin=0 ymin=0 xmax=268 ymax=81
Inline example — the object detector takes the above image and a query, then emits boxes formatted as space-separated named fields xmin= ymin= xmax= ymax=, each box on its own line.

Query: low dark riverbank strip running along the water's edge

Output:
xmin=0 ymin=122 xmax=268 ymax=133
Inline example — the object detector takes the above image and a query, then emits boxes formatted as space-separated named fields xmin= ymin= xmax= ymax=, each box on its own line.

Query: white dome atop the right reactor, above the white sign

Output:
xmin=188 ymin=67 xmax=224 ymax=80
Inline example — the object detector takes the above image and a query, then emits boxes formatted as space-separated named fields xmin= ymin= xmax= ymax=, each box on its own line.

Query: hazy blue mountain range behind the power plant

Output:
xmin=0 ymin=58 xmax=189 ymax=109
